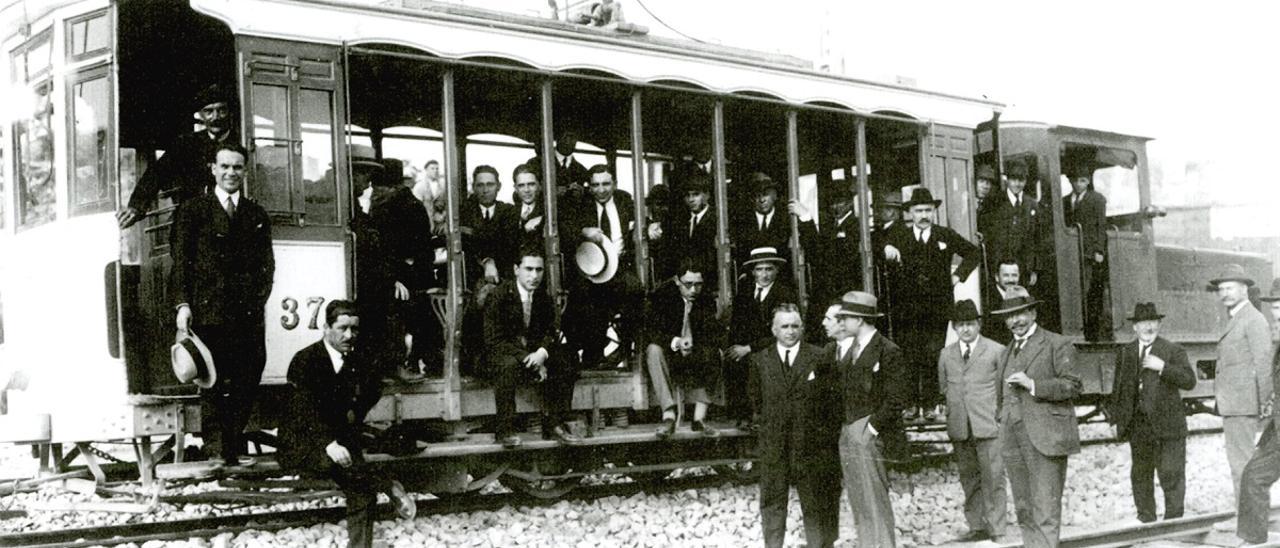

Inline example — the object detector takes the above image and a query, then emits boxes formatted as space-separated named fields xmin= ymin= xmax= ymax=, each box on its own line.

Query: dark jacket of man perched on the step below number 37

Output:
xmin=279 ymin=341 xmax=381 ymax=471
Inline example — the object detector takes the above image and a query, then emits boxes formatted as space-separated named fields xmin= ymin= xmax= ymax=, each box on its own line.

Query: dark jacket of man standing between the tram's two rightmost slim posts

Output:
xmin=800 ymin=214 xmax=863 ymax=298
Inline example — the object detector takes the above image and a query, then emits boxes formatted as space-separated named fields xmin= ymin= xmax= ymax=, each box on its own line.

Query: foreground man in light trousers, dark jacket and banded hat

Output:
xmin=823 ymin=291 xmax=908 ymax=548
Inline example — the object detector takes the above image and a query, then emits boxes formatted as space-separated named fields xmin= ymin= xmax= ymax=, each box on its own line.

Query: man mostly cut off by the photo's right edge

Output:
xmin=1235 ymin=278 xmax=1280 ymax=544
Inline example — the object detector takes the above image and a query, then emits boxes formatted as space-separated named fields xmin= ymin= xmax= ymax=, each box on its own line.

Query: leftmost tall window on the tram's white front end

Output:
xmin=13 ymin=81 xmax=58 ymax=228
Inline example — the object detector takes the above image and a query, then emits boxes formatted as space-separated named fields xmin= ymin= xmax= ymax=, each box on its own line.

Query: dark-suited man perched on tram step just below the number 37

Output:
xmin=279 ymin=300 xmax=417 ymax=547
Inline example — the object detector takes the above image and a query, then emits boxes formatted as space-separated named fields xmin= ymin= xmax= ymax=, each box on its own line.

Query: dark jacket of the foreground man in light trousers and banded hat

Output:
xmin=839 ymin=332 xmax=911 ymax=431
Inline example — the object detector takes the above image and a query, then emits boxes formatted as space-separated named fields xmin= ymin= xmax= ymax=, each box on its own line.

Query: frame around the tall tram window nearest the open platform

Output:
xmin=67 ymin=63 xmax=118 ymax=216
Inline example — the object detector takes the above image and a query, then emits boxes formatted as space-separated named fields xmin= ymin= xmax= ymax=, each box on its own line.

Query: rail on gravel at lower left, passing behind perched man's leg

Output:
xmin=0 ymin=474 xmax=745 ymax=548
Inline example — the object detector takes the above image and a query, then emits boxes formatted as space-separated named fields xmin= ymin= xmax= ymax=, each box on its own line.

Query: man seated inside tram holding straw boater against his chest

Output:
xmin=562 ymin=164 xmax=644 ymax=369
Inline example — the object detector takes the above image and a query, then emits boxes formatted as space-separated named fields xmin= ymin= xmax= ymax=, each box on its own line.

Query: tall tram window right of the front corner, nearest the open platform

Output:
xmin=68 ymin=68 xmax=115 ymax=215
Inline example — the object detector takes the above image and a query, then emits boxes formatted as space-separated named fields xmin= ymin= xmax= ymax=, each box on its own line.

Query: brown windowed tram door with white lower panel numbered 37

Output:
xmin=237 ymin=37 xmax=352 ymax=384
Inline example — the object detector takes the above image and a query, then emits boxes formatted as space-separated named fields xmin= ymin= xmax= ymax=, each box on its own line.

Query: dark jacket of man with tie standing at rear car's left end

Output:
xmin=978 ymin=192 xmax=1042 ymax=277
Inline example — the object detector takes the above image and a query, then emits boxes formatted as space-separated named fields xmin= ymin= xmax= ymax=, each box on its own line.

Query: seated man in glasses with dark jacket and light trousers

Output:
xmin=645 ymin=256 xmax=724 ymax=438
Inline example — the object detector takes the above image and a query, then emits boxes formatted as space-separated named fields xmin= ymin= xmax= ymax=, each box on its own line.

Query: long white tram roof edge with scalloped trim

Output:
xmin=191 ymin=0 xmax=1005 ymax=127
